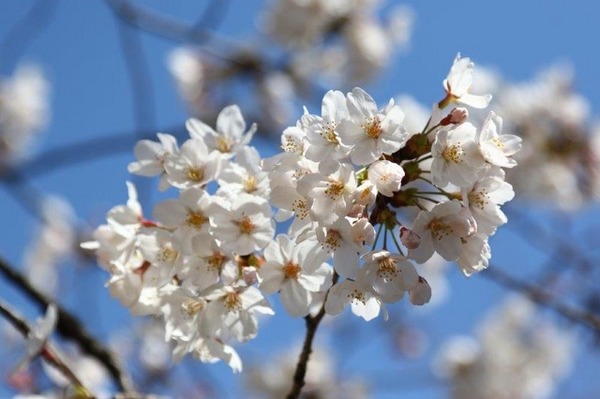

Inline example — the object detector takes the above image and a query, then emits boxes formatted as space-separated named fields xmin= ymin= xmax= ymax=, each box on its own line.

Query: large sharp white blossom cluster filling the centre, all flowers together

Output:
xmin=85 ymin=56 xmax=520 ymax=371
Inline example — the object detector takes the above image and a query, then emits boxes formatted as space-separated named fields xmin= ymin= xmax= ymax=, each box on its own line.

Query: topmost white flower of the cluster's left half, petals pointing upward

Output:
xmin=186 ymin=105 xmax=256 ymax=158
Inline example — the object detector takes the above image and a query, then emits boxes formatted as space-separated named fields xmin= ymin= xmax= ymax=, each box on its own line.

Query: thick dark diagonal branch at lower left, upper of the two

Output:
xmin=0 ymin=257 xmax=135 ymax=394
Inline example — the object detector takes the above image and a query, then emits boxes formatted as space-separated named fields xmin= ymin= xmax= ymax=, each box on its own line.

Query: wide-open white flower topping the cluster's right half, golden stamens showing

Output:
xmin=339 ymin=87 xmax=410 ymax=165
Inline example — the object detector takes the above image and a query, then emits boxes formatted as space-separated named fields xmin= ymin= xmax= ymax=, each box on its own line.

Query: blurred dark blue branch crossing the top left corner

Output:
xmin=0 ymin=0 xmax=58 ymax=71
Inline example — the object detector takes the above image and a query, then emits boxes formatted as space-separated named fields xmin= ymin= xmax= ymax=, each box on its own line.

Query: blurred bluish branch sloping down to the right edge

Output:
xmin=480 ymin=265 xmax=600 ymax=331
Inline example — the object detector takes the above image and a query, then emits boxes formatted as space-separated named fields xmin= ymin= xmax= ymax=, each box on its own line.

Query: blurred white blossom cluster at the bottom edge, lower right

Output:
xmin=436 ymin=296 xmax=576 ymax=399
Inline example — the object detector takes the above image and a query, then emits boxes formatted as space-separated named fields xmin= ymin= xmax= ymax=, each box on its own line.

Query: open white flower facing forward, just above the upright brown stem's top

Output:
xmin=259 ymin=234 xmax=333 ymax=317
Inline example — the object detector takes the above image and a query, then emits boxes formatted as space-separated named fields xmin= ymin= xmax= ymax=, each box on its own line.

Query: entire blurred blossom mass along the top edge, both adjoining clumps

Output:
xmin=168 ymin=0 xmax=414 ymax=132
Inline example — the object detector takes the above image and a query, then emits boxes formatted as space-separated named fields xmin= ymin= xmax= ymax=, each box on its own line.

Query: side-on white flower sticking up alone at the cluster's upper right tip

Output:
xmin=440 ymin=53 xmax=492 ymax=108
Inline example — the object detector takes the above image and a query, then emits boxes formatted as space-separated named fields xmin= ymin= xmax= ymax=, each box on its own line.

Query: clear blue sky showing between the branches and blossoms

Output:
xmin=0 ymin=0 xmax=600 ymax=398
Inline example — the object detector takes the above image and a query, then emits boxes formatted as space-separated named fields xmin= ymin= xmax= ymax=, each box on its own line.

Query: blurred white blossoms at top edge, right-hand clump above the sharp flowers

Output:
xmin=264 ymin=0 xmax=413 ymax=82
